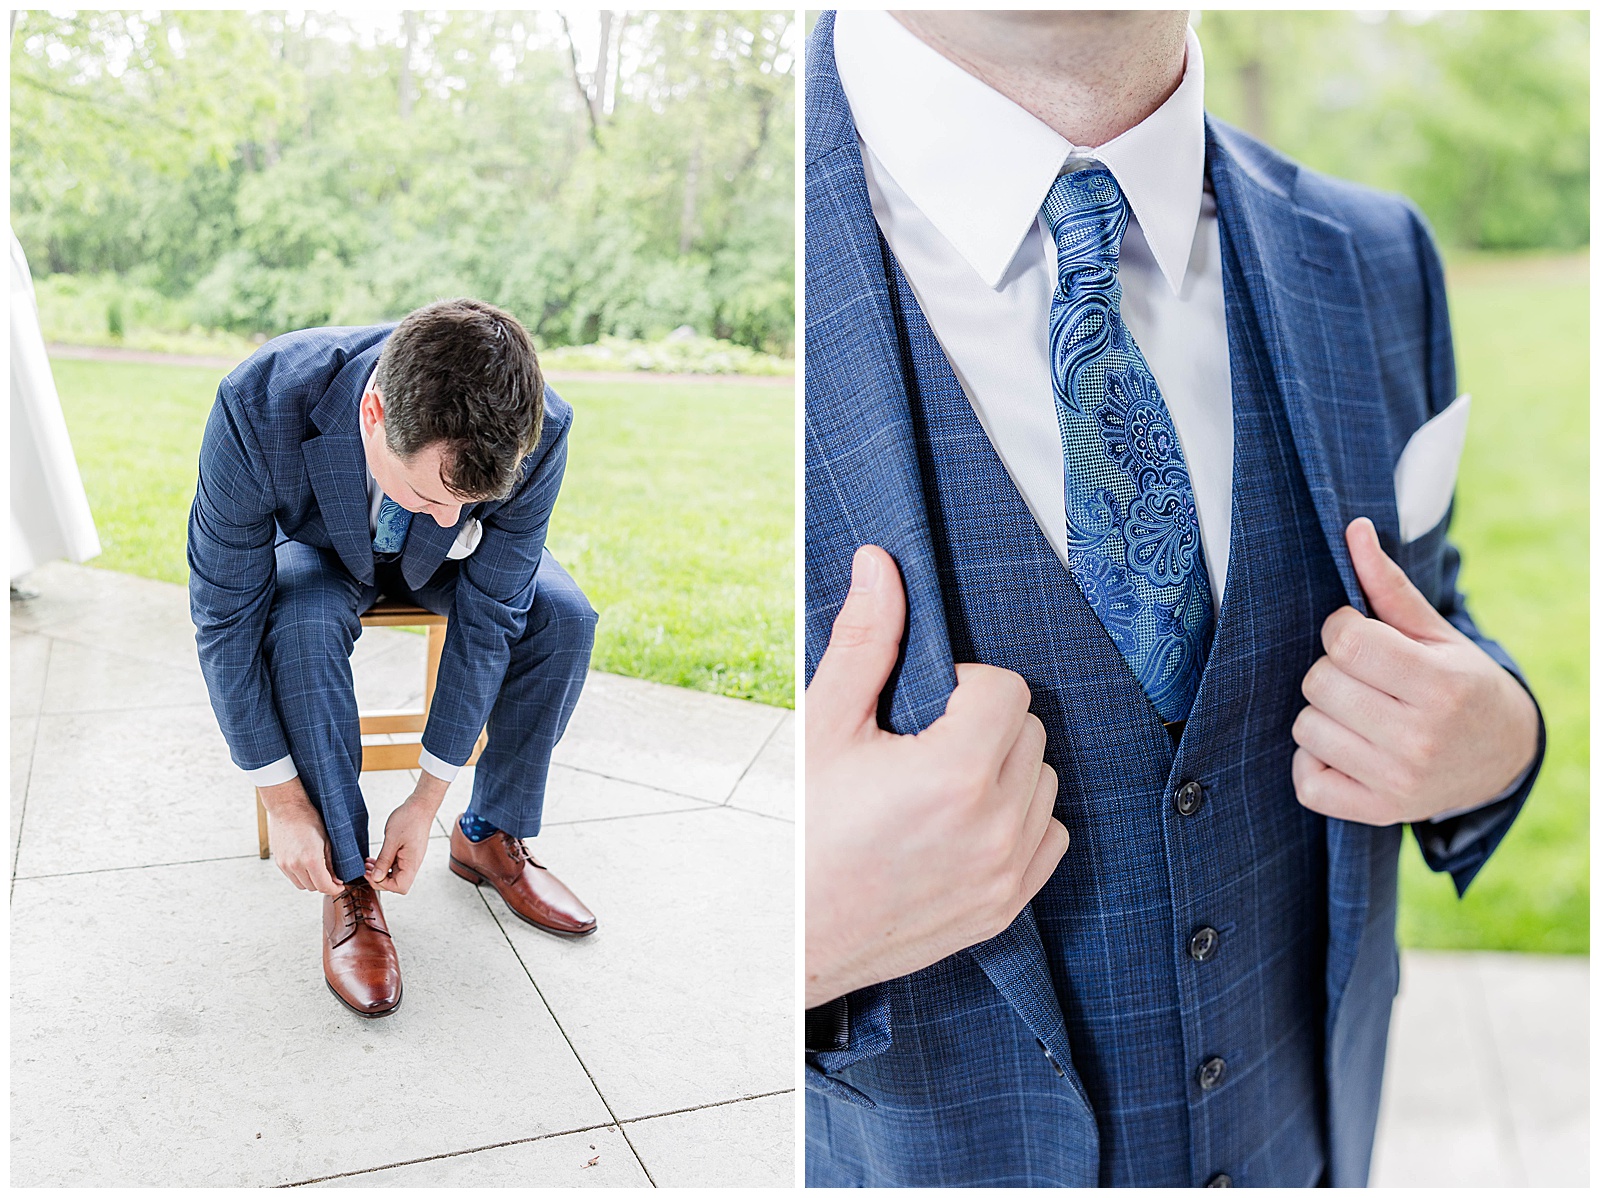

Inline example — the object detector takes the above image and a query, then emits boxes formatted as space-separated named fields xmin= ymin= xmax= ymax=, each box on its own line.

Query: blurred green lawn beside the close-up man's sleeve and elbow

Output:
xmin=1400 ymin=256 xmax=1589 ymax=953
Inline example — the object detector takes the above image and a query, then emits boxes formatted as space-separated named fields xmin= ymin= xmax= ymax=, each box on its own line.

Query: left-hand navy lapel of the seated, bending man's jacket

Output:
xmin=301 ymin=342 xmax=382 ymax=584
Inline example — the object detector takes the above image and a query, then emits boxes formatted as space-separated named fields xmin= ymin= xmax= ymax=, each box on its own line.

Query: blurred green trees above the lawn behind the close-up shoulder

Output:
xmin=1195 ymin=11 xmax=1589 ymax=250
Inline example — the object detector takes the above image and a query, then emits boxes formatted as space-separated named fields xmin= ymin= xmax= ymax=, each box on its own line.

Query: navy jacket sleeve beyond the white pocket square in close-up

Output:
xmin=1411 ymin=208 xmax=1544 ymax=894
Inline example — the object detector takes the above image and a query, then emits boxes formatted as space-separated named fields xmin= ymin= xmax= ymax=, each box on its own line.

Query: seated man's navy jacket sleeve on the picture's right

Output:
xmin=422 ymin=409 xmax=573 ymax=766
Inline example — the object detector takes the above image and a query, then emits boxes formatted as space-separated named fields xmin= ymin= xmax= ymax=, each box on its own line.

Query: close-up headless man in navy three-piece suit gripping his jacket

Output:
xmin=806 ymin=11 xmax=1544 ymax=1187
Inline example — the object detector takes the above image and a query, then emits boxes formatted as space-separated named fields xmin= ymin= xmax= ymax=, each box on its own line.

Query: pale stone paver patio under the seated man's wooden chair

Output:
xmin=11 ymin=563 xmax=795 ymax=1187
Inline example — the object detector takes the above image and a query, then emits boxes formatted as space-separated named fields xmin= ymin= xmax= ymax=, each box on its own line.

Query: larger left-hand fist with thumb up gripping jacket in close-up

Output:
xmin=805 ymin=545 xmax=1067 ymax=1008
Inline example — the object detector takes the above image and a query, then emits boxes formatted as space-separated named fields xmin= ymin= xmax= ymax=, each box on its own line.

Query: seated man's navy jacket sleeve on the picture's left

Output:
xmin=187 ymin=379 xmax=290 ymax=769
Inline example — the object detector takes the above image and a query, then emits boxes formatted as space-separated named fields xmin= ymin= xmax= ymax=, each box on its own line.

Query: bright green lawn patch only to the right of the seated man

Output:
xmin=550 ymin=382 xmax=795 ymax=707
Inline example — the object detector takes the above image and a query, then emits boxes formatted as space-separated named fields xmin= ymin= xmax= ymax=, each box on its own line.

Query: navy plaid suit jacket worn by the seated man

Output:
xmin=189 ymin=325 xmax=573 ymax=769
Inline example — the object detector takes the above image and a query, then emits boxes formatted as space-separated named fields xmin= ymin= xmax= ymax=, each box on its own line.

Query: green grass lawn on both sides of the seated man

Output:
xmin=51 ymin=358 xmax=795 ymax=707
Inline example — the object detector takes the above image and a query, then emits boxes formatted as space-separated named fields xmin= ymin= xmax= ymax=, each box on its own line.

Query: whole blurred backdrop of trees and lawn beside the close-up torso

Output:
xmin=1197 ymin=11 xmax=1589 ymax=953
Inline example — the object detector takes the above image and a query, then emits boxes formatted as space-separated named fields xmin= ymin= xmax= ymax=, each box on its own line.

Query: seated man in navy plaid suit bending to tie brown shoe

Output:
xmin=189 ymin=299 xmax=597 ymax=1017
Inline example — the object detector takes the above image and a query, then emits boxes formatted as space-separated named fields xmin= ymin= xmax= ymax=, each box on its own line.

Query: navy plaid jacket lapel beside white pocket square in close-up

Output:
xmin=1206 ymin=118 xmax=1400 ymax=613
